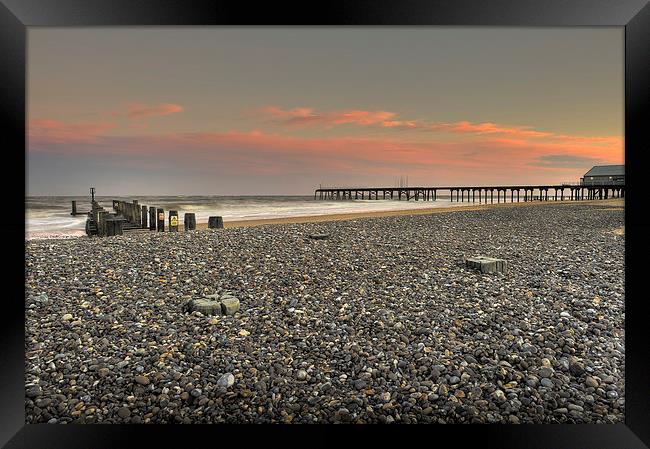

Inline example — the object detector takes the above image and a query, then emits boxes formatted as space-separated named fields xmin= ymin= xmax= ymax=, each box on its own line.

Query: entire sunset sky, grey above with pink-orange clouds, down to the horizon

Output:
xmin=27 ymin=27 xmax=624 ymax=195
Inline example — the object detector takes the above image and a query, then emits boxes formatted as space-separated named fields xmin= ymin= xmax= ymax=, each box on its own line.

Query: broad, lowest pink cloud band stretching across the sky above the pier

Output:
xmin=29 ymin=117 xmax=623 ymax=184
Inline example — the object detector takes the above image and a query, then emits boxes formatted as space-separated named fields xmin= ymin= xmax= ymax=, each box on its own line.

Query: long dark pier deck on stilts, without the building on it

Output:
xmin=314 ymin=183 xmax=625 ymax=204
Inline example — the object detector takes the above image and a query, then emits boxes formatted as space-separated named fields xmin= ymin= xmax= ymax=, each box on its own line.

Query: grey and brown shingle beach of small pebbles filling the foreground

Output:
xmin=25 ymin=201 xmax=625 ymax=423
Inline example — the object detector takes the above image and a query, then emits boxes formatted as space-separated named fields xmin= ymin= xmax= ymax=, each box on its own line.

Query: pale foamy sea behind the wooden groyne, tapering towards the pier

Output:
xmin=25 ymin=195 xmax=486 ymax=240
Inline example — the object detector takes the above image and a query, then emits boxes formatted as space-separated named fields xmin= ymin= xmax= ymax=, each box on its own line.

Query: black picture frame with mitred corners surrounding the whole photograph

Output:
xmin=0 ymin=0 xmax=650 ymax=449
